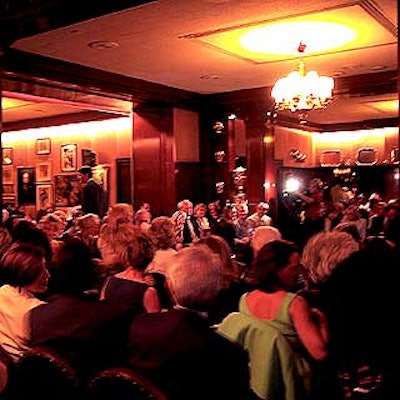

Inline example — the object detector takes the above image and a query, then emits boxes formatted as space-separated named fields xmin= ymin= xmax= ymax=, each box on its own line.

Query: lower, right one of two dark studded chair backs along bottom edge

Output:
xmin=87 ymin=367 xmax=168 ymax=400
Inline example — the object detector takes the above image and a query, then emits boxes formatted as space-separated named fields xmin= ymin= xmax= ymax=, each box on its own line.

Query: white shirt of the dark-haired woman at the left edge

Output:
xmin=0 ymin=285 xmax=45 ymax=361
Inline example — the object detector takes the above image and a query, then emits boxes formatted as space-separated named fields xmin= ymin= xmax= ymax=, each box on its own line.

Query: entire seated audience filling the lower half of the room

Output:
xmin=0 ymin=191 xmax=400 ymax=400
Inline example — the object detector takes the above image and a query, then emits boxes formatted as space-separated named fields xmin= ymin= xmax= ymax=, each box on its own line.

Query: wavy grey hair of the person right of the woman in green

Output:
xmin=302 ymin=231 xmax=360 ymax=283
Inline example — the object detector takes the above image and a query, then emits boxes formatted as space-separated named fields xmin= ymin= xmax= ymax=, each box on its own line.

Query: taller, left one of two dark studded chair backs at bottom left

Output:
xmin=16 ymin=347 xmax=81 ymax=400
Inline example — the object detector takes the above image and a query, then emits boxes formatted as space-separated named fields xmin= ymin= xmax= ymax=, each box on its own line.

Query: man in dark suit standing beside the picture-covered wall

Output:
xmin=79 ymin=165 xmax=106 ymax=217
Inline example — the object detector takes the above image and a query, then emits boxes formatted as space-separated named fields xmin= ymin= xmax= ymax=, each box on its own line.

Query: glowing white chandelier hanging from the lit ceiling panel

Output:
xmin=271 ymin=42 xmax=334 ymax=112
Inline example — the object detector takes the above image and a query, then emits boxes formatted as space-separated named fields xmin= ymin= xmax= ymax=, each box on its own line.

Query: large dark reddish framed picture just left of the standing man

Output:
xmin=54 ymin=174 xmax=81 ymax=207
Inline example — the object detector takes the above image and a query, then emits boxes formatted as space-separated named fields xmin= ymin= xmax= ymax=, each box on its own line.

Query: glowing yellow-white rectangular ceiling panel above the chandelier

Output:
xmin=188 ymin=5 xmax=397 ymax=64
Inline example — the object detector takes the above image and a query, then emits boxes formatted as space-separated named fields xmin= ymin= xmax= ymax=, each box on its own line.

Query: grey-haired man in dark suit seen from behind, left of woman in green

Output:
xmin=128 ymin=245 xmax=249 ymax=400
